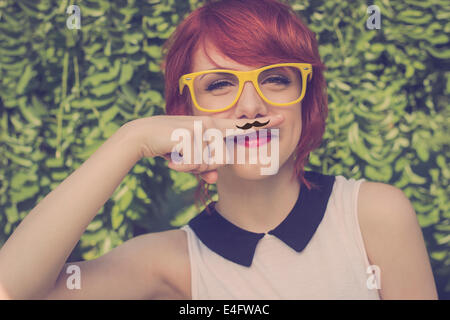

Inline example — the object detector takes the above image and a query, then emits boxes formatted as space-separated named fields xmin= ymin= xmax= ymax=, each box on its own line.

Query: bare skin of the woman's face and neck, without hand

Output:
xmin=185 ymin=42 xmax=302 ymax=232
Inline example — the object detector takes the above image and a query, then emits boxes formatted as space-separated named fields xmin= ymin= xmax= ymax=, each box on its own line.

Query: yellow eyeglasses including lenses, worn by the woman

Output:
xmin=179 ymin=63 xmax=312 ymax=112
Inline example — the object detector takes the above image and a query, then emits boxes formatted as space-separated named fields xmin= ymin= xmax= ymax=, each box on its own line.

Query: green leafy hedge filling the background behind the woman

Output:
xmin=0 ymin=0 xmax=450 ymax=298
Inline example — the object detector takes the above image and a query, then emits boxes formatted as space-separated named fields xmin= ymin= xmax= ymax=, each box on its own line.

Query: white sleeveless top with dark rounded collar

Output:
xmin=181 ymin=171 xmax=380 ymax=300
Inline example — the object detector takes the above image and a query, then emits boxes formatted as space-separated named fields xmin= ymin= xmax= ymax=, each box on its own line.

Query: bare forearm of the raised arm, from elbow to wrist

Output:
xmin=0 ymin=124 xmax=140 ymax=299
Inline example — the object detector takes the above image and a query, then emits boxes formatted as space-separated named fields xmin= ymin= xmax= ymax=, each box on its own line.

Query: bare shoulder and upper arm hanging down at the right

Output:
xmin=358 ymin=182 xmax=437 ymax=299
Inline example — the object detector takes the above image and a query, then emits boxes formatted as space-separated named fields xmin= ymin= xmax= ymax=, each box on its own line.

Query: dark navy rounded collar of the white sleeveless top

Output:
xmin=185 ymin=171 xmax=335 ymax=267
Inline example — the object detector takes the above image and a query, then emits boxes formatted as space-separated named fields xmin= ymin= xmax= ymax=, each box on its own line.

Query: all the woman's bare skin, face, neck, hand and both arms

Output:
xmin=0 ymin=40 xmax=437 ymax=299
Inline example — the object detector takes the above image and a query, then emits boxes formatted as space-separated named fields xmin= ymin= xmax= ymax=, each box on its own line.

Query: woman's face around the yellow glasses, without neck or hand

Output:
xmin=191 ymin=46 xmax=302 ymax=180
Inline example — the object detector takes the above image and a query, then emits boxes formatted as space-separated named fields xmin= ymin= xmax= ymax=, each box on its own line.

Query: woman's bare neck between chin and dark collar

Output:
xmin=215 ymin=158 xmax=300 ymax=233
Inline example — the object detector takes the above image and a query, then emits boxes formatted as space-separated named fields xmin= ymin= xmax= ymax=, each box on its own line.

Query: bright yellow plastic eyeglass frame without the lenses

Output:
xmin=178 ymin=62 xmax=313 ymax=113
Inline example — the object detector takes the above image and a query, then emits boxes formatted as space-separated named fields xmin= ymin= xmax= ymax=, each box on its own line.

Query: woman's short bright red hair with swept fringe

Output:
xmin=161 ymin=0 xmax=328 ymax=215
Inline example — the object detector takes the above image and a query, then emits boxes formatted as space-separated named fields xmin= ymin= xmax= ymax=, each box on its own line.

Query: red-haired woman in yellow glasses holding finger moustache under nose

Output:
xmin=0 ymin=0 xmax=437 ymax=299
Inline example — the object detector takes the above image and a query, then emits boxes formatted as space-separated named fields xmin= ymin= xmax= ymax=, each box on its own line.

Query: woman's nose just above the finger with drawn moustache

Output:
xmin=235 ymin=81 xmax=267 ymax=119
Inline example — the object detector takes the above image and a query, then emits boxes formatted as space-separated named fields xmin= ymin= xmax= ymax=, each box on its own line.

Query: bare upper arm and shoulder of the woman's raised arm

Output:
xmin=45 ymin=229 xmax=190 ymax=300
